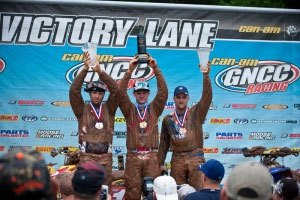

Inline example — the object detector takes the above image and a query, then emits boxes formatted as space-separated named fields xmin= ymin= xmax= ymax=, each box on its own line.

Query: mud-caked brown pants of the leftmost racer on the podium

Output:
xmin=79 ymin=152 xmax=112 ymax=189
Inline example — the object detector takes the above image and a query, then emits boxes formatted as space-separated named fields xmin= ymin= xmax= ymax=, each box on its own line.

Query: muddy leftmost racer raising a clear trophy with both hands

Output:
xmin=69 ymin=52 xmax=119 ymax=185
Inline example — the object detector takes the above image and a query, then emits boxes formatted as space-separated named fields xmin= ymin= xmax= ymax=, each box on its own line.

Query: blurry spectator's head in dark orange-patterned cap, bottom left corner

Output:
xmin=0 ymin=147 xmax=55 ymax=200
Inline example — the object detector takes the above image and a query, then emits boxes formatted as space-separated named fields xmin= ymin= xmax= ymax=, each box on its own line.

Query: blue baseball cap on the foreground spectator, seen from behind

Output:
xmin=198 ymin=159 xmax=225 ymax=181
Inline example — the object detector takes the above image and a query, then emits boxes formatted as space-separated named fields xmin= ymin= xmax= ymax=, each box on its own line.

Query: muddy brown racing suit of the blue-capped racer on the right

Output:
xmin=158 ymin=74 xmax=212 ymax=190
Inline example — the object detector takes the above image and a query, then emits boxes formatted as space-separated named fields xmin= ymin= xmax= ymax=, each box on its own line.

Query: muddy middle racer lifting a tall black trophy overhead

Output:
xmin=119 ymin=56 xmax=168 ymax=200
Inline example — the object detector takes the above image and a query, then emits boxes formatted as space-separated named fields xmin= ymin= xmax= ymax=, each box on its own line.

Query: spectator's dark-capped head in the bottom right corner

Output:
xmin=273 ymin=177 xmax=299 ymax=200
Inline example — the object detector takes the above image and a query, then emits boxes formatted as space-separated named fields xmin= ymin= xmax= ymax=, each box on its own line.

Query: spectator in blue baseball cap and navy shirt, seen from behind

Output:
xmin=185 ymin=159 xmax=225 ymax=200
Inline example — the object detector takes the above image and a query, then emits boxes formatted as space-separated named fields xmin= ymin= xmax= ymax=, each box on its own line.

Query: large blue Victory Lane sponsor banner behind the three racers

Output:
xmin=0 ymin=0 xmax=300 ymax=180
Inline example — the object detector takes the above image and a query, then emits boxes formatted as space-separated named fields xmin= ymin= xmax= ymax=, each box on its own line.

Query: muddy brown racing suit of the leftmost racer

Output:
xmin=69 ymin=69 xmax=119 ymax=185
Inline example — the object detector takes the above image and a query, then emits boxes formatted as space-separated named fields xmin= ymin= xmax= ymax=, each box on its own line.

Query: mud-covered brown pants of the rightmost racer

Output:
xmin=171 ymin=153 xmax=205 ymax=191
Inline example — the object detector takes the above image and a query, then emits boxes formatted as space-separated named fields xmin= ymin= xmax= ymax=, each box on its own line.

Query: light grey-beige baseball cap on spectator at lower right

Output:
xmin=225 ymin=162 xmax=273 ymax=200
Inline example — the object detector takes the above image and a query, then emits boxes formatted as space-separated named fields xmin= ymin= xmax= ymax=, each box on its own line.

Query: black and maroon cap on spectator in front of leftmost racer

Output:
xmin=72 ymin=160 xmax=106 ymax=195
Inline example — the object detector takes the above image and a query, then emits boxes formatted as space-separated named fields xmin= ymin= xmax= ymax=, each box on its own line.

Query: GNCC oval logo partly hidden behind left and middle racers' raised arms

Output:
xmin=66 ymin=57 xmax=154 ymax=88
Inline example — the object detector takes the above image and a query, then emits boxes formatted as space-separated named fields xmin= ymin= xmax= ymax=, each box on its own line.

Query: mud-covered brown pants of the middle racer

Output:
xmin=124 ymin=152 xmax=160 ymax=200
